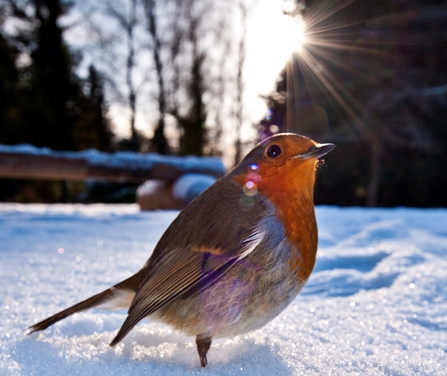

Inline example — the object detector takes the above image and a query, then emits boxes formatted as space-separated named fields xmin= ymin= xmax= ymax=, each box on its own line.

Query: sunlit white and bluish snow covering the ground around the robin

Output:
xmin=0 ymin=204 xmax=447 ymax=375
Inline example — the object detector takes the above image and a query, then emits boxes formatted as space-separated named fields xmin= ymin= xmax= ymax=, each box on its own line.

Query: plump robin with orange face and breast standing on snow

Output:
xmin=30 ymin=133 xmax=335 ymax=367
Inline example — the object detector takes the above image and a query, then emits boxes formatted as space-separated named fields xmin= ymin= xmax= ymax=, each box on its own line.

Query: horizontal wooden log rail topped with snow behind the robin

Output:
xmin=0 ymin=144 xmax=225 ymax=183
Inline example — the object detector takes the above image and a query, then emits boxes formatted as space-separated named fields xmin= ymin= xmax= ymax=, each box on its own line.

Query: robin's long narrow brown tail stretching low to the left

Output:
xmin=28 ymin=270 xmax=144 ymax=334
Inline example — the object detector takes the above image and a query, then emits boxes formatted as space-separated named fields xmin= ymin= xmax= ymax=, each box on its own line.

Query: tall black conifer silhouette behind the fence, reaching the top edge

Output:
xmin=30 ymin=0 xmax=77 ymax=150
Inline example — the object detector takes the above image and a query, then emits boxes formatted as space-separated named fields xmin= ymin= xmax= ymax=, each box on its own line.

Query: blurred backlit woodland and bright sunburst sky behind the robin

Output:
xmin=0 ymin=0 xmax=447 ymax=207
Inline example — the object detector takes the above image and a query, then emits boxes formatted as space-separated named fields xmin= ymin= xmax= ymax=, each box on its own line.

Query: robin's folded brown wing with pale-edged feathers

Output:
xmin=110 ymin=177 xmax=265 ymax=346
